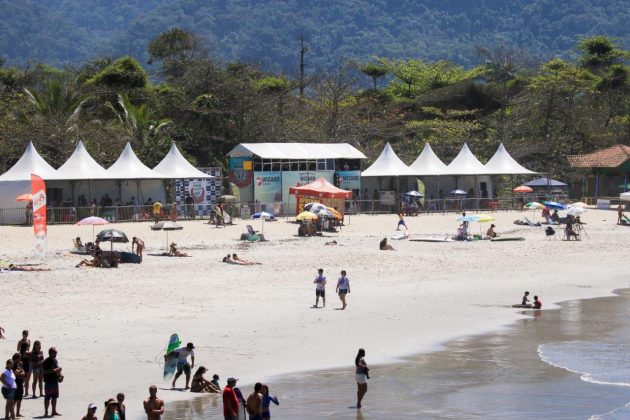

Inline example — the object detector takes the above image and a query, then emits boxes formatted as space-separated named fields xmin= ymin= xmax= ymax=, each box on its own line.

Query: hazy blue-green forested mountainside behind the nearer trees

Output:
xmin=0 ymin=0 xmax=630 ymax=70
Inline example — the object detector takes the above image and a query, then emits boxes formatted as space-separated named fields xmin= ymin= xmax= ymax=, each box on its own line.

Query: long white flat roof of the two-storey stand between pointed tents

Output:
xmin=228 ymin=143 xmax=367 ymax=160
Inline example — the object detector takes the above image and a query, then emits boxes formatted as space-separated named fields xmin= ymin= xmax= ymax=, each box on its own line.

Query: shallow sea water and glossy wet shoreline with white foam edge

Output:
xmin=165 ymin=290 xmax=630 ymax=420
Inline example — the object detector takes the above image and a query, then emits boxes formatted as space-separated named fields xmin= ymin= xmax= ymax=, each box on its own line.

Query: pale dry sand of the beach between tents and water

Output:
xmin=0 ymin=210 xmax=630 ymax=418
